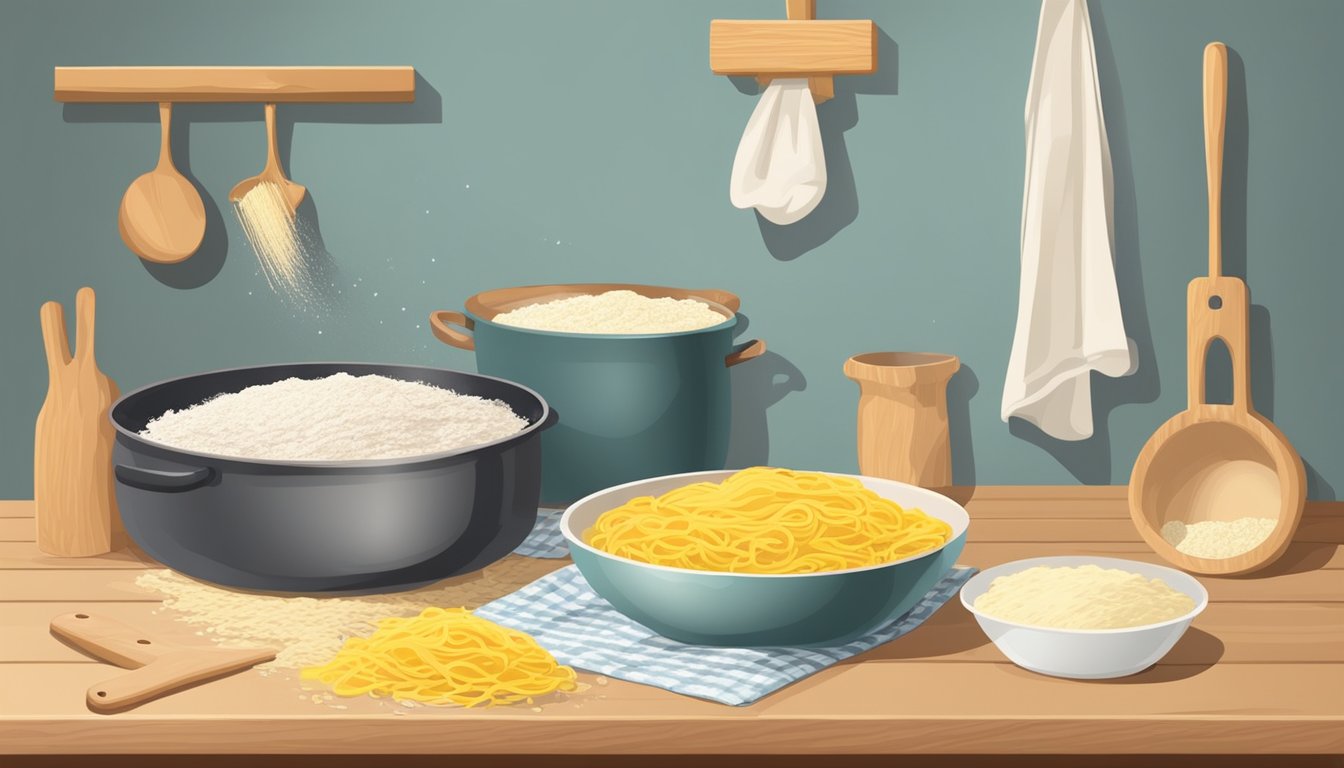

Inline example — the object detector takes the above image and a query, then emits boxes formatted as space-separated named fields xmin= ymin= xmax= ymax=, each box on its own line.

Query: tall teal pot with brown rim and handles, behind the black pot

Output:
xmin=430 ymin=284 xmax=765 ymax=503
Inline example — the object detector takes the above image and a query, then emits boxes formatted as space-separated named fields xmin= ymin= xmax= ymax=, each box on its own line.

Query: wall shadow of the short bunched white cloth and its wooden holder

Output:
xmin=730 ymin=30 xmax=899 ymax=261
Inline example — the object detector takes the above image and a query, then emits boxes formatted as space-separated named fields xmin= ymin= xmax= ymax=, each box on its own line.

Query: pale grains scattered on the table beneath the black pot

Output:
xmin=136 ymin=557 xmax=554 ymax=670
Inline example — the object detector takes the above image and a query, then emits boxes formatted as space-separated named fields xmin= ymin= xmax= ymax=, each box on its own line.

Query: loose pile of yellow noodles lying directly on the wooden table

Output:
xmin=301 ymin=608 xmax=578 ymax=706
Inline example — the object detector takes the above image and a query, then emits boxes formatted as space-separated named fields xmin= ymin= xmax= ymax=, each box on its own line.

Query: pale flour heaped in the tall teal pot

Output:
xmin=495 ymin=291 xmax=727 ymax=334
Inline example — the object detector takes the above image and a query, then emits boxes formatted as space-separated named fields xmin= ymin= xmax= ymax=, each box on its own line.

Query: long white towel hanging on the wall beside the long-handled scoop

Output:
xmin=1003 ymin=0 xmax=1133 ymax=440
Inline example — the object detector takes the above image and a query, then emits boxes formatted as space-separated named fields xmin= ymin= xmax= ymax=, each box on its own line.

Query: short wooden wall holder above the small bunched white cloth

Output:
xmin=710 ymin=0 xmax=878 ymax=104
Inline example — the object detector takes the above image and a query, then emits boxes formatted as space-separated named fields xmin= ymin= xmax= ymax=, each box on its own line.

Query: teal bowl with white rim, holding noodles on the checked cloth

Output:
xmin=560 ymin=469 xmax=970 ymax=647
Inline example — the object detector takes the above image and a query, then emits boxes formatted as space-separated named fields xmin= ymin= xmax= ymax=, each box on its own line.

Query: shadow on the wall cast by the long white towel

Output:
xmin=1008 ymin=4 xmax=1166 ymax=484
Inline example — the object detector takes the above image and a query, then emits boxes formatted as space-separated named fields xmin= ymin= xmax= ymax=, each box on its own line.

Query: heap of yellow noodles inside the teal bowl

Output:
xmin=585 ymin=467 xmax=952 ymax=573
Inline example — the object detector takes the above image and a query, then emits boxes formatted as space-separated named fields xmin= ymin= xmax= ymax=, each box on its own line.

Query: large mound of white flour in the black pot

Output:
xmin=140 ymin=373 xmax=527 ymax=461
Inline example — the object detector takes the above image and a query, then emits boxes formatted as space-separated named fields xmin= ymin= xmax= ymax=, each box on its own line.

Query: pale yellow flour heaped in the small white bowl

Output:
xmin=974 ymin=565 xmax=1195 ymax=629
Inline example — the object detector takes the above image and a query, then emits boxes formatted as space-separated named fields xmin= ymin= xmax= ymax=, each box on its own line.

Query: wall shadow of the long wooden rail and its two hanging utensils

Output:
xmin=62 ymin=73 xmax=444 ymax=289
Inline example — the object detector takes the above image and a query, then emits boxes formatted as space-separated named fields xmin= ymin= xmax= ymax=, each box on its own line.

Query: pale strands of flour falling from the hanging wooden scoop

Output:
xmin=238 ymin=182 xmax=317 ymax=300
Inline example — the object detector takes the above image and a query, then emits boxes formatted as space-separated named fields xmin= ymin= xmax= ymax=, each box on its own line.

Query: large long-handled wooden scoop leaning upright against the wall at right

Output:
xmin=1129 ymin=43 xmax=1306 ymax=576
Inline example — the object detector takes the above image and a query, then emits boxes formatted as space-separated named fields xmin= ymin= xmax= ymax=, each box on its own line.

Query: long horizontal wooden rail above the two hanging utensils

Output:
xmin=55 ymin=67 xmax=415 ymax=104
